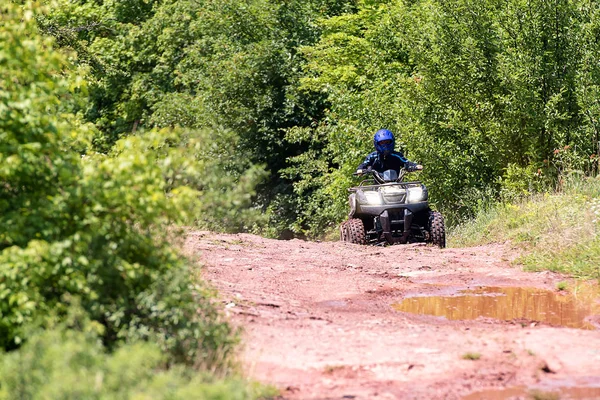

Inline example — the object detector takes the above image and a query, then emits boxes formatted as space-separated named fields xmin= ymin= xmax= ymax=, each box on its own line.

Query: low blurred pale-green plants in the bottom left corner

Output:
xmin=0 ymin=309 xmax=276 ymax=400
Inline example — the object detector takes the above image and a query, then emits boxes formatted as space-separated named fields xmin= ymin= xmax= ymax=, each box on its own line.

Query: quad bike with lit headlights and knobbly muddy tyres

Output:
xmin=340 ymin=169 xmax=446 ymax=248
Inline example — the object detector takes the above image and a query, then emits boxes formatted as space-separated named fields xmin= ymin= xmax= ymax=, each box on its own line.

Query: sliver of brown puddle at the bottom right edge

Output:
xmin=462 ymin=386 xmax=600 ymax=400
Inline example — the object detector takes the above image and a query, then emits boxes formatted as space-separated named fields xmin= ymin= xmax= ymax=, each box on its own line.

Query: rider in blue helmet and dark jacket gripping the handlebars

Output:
xmin=356 ymin=129 xmax=423 ymax=243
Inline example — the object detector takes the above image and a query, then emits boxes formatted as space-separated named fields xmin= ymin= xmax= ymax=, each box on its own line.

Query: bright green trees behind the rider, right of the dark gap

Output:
xmin=287 ymin=0 xmax=598 ymax=233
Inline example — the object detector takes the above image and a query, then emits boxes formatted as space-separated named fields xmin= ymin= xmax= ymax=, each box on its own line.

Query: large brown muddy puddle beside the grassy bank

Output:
xmin=393 ymin=287 xmax=600 ymax=329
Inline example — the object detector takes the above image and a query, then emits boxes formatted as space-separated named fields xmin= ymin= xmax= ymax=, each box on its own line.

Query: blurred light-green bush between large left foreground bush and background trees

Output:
xmin=110 ymin=128 xmax=266 ymax=231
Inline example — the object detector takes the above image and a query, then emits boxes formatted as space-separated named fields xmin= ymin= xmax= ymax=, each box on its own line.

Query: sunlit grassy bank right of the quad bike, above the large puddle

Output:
xmin=449 ymin=175 xmax=600 ymax=279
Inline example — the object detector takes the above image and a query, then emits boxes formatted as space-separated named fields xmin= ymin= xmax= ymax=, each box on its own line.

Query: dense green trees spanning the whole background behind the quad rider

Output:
xmin=39 ymin=0 xmax=600 ymax=235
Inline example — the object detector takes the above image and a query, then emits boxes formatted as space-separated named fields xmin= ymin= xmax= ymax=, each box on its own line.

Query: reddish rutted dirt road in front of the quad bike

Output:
xmin=186 ymin=232 xmax=600 ymax=399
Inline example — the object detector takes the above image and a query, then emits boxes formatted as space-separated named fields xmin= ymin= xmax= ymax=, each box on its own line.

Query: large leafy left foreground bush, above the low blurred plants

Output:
xmin=0 ymin=3 xmax=236 ymax=367
